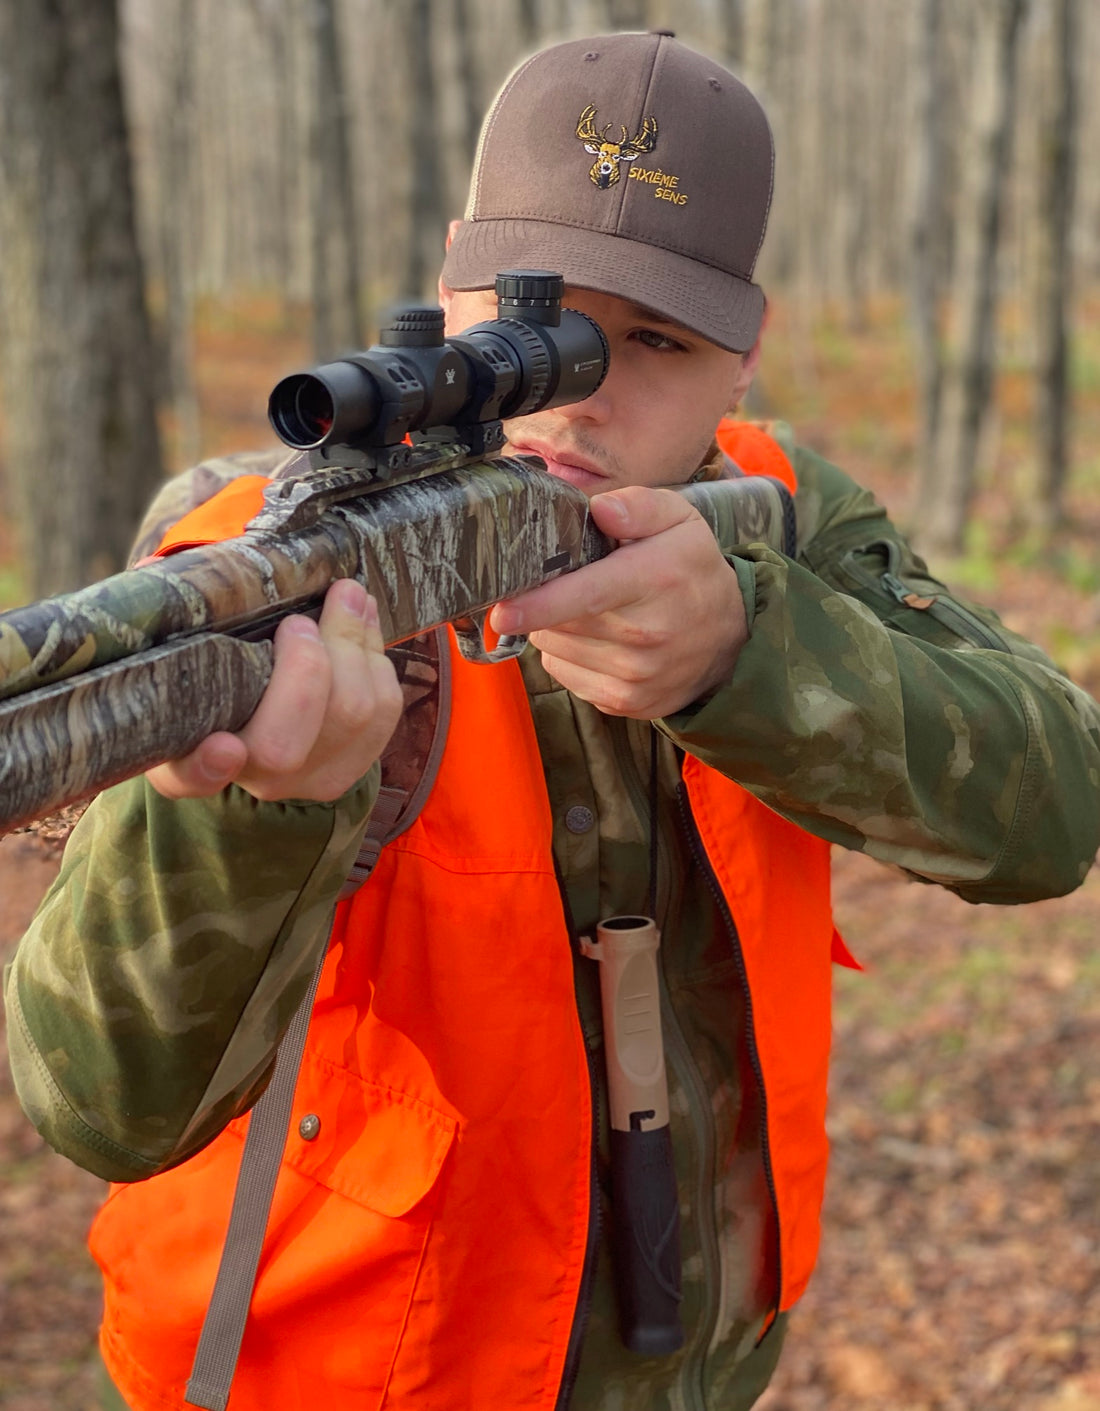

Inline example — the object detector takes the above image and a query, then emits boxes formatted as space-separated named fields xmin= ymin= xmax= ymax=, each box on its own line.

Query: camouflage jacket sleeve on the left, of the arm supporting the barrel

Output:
xmin=4 ymin=765 xmax=378 ymax=1181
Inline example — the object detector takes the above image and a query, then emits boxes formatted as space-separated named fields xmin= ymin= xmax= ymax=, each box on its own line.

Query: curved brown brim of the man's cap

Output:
xmin=443 ymin=220 xmax=764 ymax=353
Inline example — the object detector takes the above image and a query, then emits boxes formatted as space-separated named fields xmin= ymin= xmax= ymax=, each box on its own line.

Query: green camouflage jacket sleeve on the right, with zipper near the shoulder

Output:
xmin=661 ymin=452 xmax=1100 ymax=903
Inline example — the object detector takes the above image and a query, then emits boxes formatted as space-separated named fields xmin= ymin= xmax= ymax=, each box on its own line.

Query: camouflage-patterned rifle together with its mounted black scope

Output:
xmin=0 ymin=271 xmax=794 ymax=832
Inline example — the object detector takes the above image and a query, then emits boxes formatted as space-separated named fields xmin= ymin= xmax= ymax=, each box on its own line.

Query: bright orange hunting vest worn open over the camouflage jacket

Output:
xmin=90 ymin=426 xmax=835 ymax=1411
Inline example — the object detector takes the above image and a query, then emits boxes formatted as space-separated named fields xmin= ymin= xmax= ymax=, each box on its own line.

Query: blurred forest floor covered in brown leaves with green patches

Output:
xmin=0 ymin=292 xmax=1100 ymax=1411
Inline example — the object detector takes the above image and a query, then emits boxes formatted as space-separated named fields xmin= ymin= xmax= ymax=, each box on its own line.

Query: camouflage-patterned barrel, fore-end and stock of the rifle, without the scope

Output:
xmin=0 ymin=449 xmax=790 ymax=832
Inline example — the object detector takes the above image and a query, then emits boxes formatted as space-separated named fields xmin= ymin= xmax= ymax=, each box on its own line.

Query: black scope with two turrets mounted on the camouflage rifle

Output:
xmin=268 ymin=270 xmax=609 ymax=460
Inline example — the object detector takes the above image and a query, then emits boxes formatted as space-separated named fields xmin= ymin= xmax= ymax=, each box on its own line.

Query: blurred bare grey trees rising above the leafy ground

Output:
xmin=0 ymin=0 xmax=1100 ymax=595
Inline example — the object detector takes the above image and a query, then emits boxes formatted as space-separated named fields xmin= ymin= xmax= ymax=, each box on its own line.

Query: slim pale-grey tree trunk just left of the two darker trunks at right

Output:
xmin=908 ymin=0 xmax=943 ymax=505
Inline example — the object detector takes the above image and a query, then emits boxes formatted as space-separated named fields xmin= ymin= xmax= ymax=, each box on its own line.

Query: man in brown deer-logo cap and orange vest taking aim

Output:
xmin=7 ymin=34 xmax=1100 ymax=1411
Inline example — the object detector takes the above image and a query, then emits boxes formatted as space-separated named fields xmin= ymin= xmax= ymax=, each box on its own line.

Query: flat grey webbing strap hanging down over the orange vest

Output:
xmin=183 ymin=917 xmax=331 ymax=1411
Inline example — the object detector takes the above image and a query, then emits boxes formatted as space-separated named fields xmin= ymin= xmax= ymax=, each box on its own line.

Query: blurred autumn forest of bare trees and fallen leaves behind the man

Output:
xmin=0 ymin=0 xmax=1100 ymax=1411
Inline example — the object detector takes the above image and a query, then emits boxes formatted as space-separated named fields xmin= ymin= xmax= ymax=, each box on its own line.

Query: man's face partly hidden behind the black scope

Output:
xmin=441 ymin=288 xmax=757 ymax=495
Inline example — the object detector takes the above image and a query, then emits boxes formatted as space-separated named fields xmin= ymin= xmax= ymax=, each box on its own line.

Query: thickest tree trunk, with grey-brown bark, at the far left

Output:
xmin=0 ymin=0 xmax=162 ymax=597
